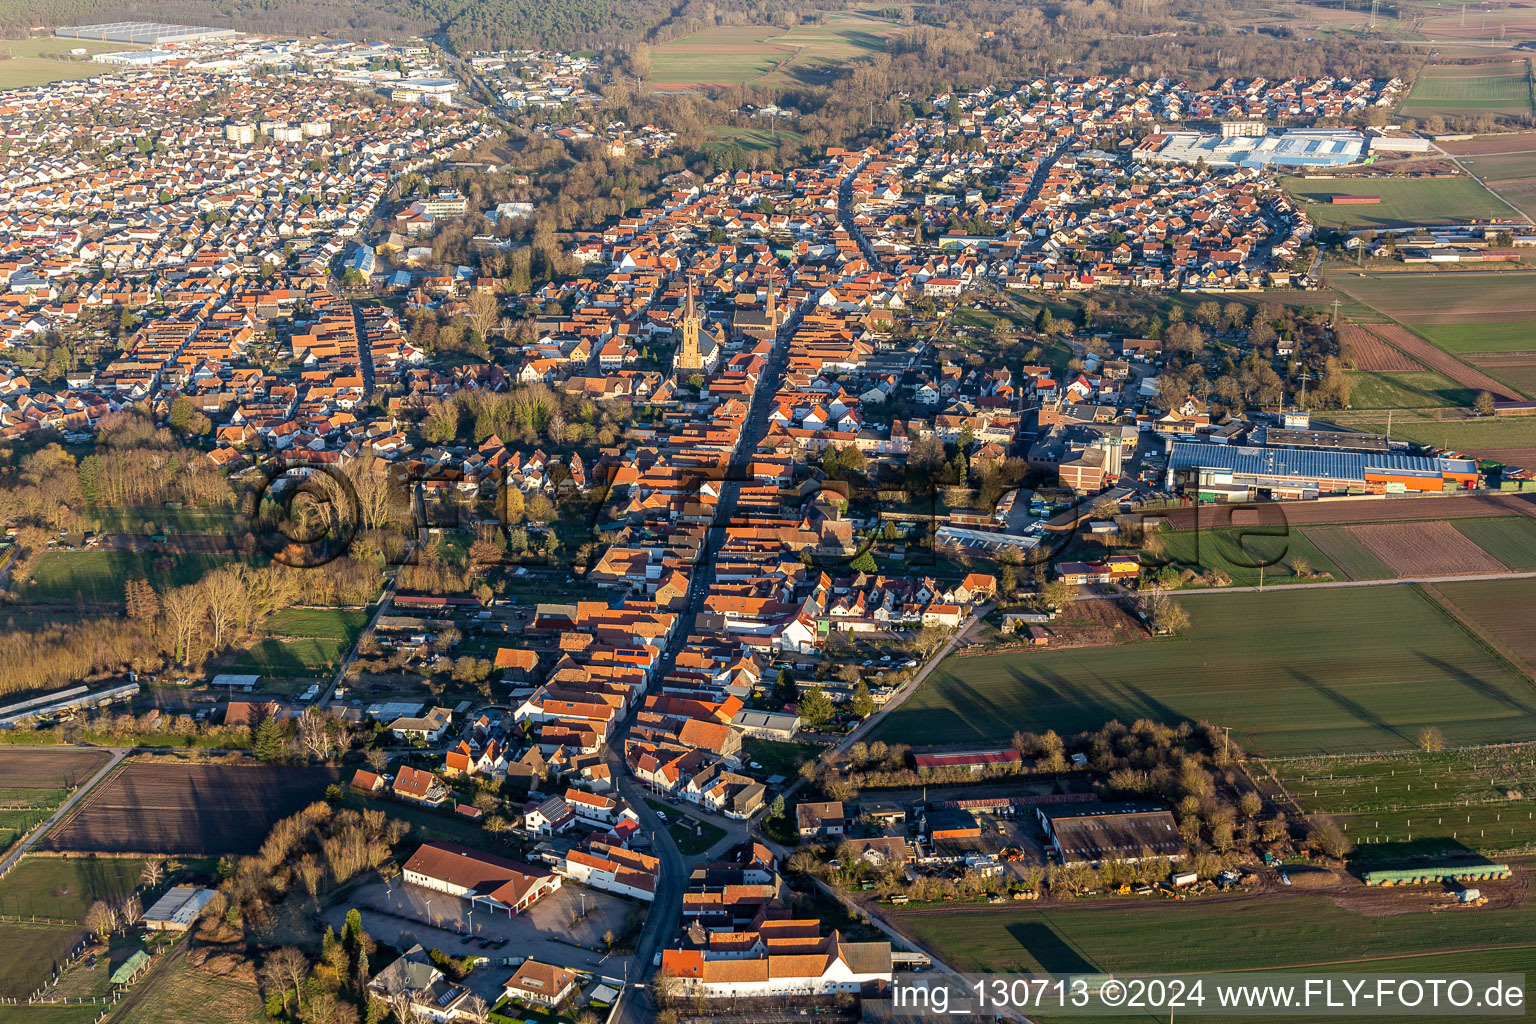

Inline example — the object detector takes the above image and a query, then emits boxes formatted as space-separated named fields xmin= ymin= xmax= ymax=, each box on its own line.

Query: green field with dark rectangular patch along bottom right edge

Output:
xmin=888 ymin=894 xmax=1536 ymax=1021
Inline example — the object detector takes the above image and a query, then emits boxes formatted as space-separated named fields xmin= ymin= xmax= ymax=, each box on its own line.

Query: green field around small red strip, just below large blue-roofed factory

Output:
xmin=1281 ymin=178 xmax=1514 ymax=227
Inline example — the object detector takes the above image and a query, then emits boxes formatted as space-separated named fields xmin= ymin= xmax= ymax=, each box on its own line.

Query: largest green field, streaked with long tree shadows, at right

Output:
xmin=872 ymin=586 xmax=1536 ymax=755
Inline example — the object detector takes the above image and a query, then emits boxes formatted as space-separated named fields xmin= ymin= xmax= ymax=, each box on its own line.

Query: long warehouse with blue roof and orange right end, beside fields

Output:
xmin=1167 ymin=442 xmax=1478 ymax=502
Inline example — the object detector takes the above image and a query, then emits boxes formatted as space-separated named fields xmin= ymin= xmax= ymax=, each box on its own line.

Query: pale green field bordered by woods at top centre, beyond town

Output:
xmin=650 ymin=14 xmax=899 ymax=86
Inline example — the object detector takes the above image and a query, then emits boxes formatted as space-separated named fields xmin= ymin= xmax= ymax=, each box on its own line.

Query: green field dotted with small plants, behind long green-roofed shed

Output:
xmin=1267 ymin=743 xmax=1536 ymax=861
